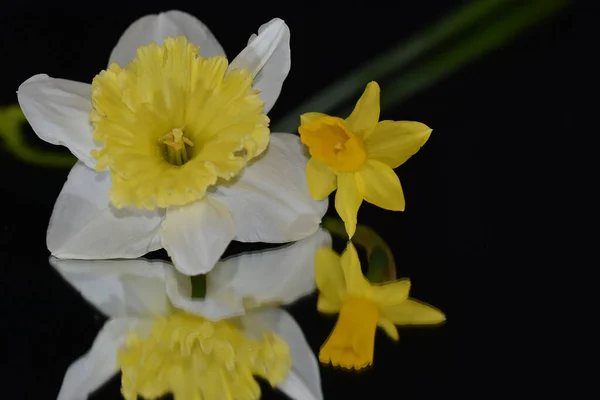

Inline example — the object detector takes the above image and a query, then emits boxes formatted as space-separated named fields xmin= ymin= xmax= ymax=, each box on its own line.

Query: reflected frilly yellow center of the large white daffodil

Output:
xmin=118 ymin=312 xmax=291 ymax=400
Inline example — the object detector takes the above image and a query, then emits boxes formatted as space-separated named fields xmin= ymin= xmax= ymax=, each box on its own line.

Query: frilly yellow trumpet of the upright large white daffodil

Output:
xmin=91 ymin=37 xmax=269 ymax=209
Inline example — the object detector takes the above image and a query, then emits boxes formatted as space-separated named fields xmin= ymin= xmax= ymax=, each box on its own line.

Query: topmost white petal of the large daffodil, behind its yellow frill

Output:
xmin=108 ymin=10 xmax=225 ymax=67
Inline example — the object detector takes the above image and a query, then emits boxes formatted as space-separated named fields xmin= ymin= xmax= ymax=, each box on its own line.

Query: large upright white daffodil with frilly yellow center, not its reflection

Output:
xmin=17 ymin=11 xmax=327 ymax=275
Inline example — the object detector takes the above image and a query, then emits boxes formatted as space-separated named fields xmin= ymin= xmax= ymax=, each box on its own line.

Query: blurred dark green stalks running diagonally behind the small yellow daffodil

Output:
xmin=272 ymin=0 xmax=568 ymax=132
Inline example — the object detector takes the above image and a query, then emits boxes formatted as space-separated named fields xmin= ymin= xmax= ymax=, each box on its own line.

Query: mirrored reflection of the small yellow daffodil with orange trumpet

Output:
xmin=315 ymin=242 xmax=446 ymax=369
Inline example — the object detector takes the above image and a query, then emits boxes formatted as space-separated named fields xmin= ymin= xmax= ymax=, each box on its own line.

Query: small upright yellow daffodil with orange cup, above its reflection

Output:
xmin=298 ymin=82 xmax=431 ymax=237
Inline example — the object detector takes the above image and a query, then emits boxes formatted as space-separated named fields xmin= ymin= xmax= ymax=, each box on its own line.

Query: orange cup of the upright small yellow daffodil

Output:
xmin=298 ymin=116 xmax=367 ymax=172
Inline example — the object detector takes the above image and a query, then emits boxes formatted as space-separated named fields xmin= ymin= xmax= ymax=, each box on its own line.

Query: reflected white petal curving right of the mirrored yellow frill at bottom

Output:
xmin=244 ymin=308 xmax=323 ymax=400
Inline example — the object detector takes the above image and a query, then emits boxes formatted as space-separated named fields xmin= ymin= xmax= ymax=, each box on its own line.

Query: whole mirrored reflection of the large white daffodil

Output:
xmin=50 ymin=231 xmax=331 ymax=400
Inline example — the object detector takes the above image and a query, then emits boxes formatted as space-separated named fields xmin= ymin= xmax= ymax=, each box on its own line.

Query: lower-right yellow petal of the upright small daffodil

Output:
xmin=359 ymin=160 xmax=405 ymax=211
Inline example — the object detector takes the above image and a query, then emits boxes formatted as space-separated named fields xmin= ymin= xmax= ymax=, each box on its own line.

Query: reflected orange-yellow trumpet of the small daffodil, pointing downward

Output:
xmin=319 ymin=298 xmax=379 ymax=370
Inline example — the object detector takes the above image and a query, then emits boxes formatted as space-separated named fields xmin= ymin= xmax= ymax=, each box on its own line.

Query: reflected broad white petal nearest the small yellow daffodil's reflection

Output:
xmin=207 ymin=229 xmax=331 ymax=306
